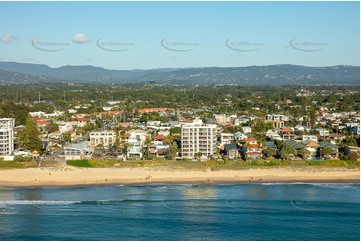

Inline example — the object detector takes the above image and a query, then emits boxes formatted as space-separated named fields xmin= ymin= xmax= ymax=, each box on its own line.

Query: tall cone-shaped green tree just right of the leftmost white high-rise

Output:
xmin=19 ymin=115 xmax=43 ymax=151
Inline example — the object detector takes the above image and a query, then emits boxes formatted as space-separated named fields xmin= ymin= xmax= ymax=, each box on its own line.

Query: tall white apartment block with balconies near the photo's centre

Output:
xmin=181 ymin=122 xmax=217 ymax=159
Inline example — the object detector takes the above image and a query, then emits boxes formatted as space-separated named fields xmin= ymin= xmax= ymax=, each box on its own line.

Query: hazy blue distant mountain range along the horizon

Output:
xmin=0 ymin=62 xmax=360 ymax=85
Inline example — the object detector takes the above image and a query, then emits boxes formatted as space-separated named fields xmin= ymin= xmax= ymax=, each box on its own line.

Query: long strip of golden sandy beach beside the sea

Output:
xmin=0 ymin=166 xmax=360 ymax=187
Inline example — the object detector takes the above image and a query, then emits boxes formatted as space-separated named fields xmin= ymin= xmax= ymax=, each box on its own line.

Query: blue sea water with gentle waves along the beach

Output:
xmin=0 ymin=184 xmax=360 ymax=241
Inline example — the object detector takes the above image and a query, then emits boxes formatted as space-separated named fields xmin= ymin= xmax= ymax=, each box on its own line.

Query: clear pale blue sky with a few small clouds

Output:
xmin=0 ymin=1 xmax=360 ymax=70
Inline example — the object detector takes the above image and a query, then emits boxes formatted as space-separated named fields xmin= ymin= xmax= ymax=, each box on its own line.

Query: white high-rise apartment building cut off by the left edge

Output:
xmin=0 ymin=118 xmax=15 ymax=156
